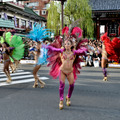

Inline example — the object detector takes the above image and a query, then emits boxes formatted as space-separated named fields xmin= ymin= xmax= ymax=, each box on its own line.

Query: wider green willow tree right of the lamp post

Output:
xmin=64 ymin=0 xmax=94 ymax=37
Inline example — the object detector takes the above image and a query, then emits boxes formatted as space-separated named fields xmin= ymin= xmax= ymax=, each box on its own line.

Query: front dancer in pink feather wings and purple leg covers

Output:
xmin=43 ymin=27 xmax=87 ymax=110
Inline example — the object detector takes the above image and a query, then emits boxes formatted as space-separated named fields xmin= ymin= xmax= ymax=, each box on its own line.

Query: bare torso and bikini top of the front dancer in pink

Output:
xmin=60 ymin=53 xmax=75 ymax=74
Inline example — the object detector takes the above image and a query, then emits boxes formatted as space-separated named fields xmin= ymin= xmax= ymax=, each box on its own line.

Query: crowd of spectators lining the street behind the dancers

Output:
xmin=0 ymin=38 xmax=115 ymax=67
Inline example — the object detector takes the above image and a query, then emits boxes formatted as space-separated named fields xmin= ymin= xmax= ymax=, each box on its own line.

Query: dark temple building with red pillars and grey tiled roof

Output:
xmin=89 ymin=0 xmax=120 ymax=39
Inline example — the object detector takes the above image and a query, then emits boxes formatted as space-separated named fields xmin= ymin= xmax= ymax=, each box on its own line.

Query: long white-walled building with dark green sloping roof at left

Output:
xmin=0 ymin=2 xmax=46 ymax=35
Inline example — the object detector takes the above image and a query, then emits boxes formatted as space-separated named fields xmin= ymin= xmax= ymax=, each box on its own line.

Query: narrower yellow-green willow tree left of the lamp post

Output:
xmin=47 ymin=1 xmax=60 ymax=35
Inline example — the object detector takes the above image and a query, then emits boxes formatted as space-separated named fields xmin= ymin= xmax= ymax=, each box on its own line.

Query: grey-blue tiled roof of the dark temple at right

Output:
xmin=89 ymin=0 xmax=120 ymax=10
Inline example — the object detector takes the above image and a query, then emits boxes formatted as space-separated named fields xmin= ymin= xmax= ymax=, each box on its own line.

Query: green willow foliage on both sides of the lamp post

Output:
xmin=47 ymin=0 xmax=94 ymax=38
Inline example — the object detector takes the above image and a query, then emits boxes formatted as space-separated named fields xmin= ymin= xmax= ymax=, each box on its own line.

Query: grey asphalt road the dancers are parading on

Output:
xmin=0 ymin=65 xmax=120 ymax=120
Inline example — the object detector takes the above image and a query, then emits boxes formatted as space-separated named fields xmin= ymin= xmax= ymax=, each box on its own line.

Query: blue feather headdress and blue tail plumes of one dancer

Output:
xmin=28 ymin=24 xmax=50 ymax=65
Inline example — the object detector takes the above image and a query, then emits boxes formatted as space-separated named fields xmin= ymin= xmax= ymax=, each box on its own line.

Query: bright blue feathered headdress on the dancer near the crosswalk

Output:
xmin=27 ymin=24 xmax=50 ymax=42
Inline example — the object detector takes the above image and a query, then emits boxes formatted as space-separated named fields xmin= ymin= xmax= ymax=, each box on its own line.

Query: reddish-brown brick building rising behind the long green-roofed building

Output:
xmin=24 ymin=0 xmax=50 ymax=19
